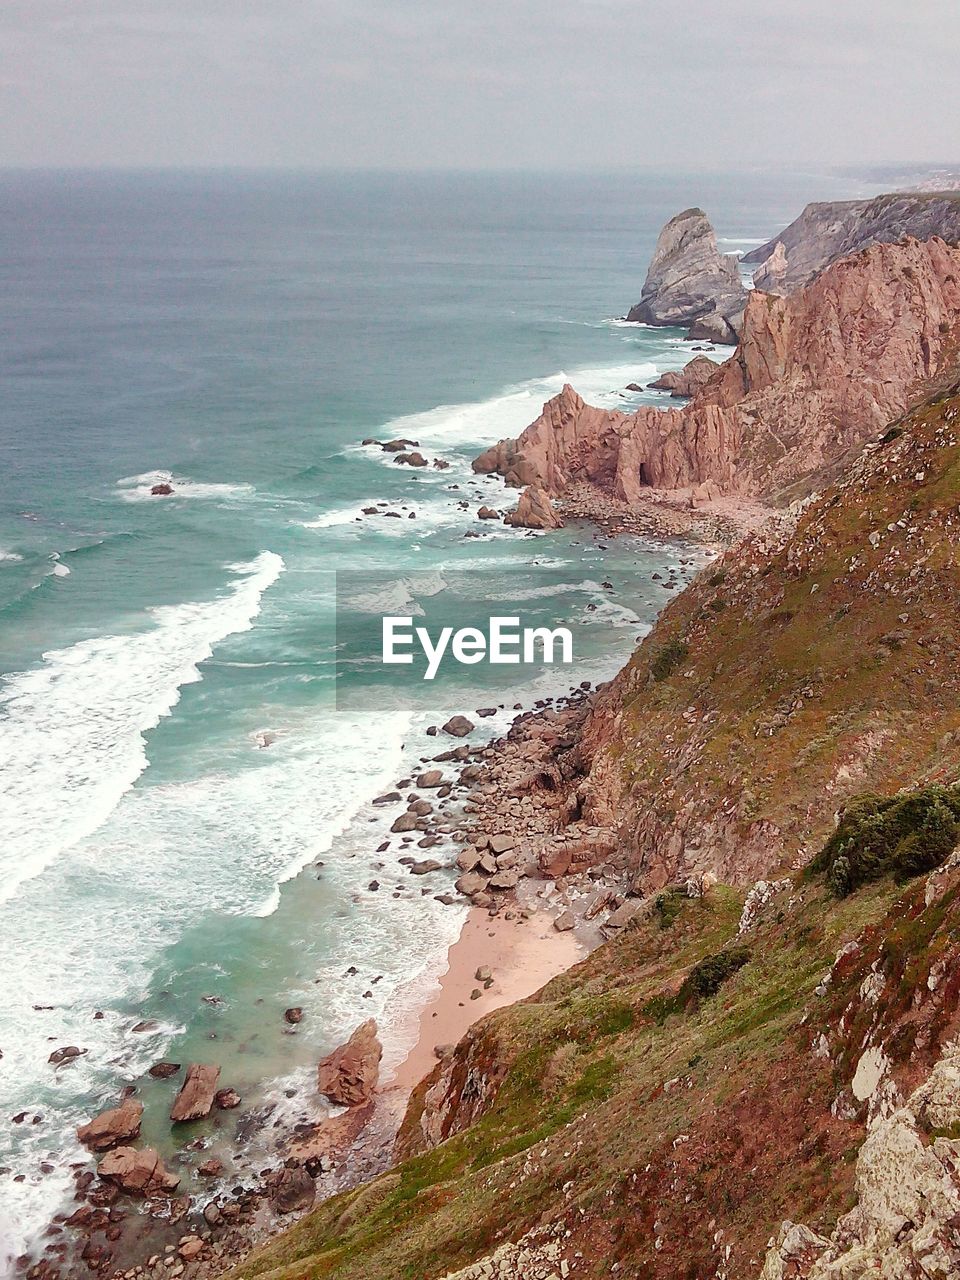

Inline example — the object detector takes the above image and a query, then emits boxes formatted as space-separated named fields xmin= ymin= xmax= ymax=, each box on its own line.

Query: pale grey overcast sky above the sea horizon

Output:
xmin=0 ymin=0 xmax=960 ymax=169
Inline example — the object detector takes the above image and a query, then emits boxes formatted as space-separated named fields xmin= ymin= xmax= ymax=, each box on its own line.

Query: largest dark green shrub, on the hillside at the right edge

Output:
xmin=810 ymin=786 xmax=960 ymax=897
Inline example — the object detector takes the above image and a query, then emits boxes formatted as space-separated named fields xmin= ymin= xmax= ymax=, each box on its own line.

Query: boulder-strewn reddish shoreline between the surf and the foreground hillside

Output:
xmin=17 ymin=660 xmax=675 ymax=1280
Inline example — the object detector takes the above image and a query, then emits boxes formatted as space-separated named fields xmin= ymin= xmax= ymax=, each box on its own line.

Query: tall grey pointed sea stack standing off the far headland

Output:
xmin=627 ymin=209 xmax=746 ymax=342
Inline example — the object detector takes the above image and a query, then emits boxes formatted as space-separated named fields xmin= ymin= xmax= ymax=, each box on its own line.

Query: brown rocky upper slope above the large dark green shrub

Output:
xmin=570 ymin=368 xmax=960 ymax=892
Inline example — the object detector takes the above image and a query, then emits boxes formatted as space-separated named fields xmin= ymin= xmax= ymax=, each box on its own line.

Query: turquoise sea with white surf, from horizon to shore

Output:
xmin=0 ymin=165 xmax=870 ymax=1253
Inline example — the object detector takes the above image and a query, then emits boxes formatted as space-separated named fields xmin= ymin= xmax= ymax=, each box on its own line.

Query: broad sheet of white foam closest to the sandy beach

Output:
xmin=0 ymin=708 xmax=409 ymax=1253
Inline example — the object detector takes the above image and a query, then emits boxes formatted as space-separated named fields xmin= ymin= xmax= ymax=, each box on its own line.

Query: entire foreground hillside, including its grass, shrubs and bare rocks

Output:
xmin=225 ymin=374 xmax=960 ymax=1280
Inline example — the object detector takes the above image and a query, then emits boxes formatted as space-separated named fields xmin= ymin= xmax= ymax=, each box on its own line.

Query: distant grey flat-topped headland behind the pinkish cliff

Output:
xmin=742 ymin=192 xmax=960 ymax=293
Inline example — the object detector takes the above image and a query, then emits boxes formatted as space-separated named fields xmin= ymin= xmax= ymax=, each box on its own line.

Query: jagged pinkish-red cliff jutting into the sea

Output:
xmin=474 ymin=238 xmax=960 ymax=502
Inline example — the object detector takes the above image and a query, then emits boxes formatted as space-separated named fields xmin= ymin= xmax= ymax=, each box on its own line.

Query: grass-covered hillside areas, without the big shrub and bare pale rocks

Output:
xmin=237 ymin=393 xmax=960 ymax=1280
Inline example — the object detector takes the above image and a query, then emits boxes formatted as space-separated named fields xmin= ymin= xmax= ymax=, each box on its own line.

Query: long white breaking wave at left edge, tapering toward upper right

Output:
xmin=0 ymin=552 xmax=283 ymax=901
